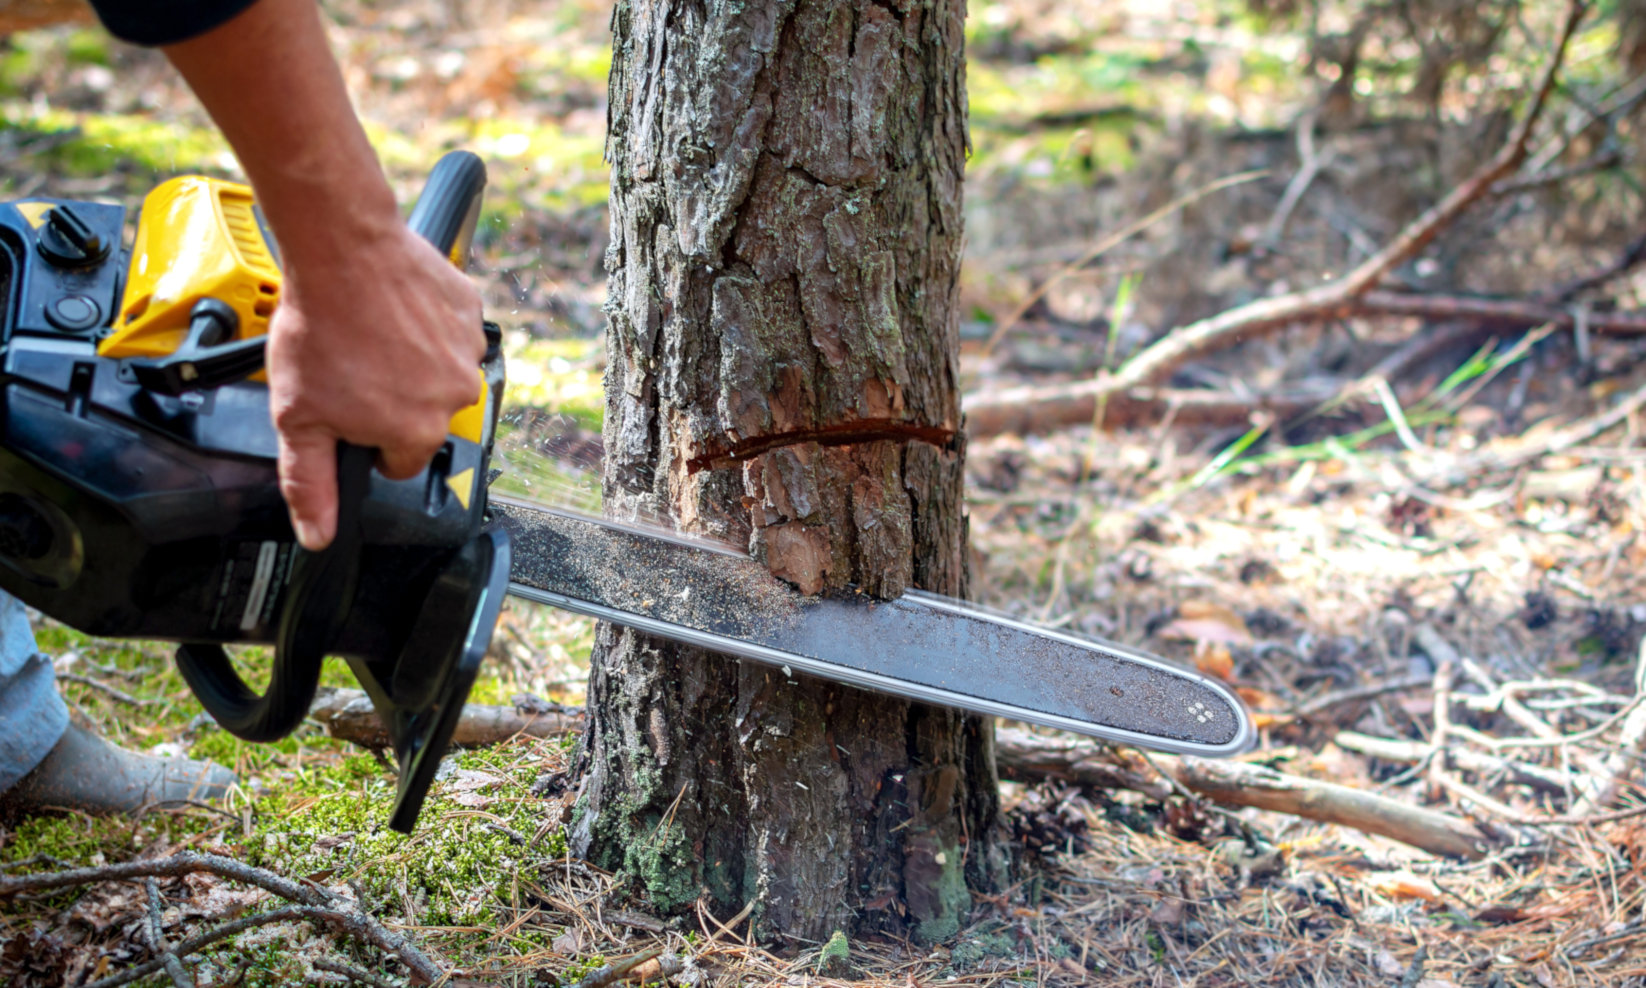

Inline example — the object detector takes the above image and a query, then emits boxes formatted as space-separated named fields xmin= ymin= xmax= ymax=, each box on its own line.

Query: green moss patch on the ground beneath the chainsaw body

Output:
xmin=0 ymin=614 xmax=586 ymax=986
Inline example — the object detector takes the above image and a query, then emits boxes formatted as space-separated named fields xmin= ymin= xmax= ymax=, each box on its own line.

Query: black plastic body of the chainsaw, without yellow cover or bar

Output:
xmin=0 ymin=156 xmax=509 ymax=830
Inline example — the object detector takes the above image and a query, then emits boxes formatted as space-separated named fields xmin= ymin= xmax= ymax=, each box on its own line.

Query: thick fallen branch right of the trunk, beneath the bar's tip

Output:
xmin=994 ymin=728 xmax=1493 ymax=860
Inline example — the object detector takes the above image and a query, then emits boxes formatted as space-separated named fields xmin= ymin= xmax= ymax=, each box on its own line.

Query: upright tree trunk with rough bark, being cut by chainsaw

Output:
xmin=573 ymin=0 xmax=1006 ymax=940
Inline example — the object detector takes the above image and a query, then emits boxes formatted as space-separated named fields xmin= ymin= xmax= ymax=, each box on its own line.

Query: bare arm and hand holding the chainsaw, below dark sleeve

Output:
xmin=165 ymin=0 xmax=486 ymax=550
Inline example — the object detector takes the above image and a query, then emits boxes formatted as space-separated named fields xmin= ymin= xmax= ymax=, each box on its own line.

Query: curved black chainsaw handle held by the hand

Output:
xmin=176 ymin=151 xmax=486 ymax=743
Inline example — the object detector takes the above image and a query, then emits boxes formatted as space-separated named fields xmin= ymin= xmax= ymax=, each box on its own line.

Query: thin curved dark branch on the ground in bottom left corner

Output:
xmin=0 ymin=851 xmax=444 ymax=985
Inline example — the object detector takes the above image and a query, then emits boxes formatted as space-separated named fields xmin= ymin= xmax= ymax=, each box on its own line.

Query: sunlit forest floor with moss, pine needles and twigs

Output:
xmin=0 ymin=0 xmax=1646 ymax=988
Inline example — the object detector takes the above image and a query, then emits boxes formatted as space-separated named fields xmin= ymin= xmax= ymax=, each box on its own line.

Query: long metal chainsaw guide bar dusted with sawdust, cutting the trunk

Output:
xmin=491 ymin=494 xmax=1256 ymax=757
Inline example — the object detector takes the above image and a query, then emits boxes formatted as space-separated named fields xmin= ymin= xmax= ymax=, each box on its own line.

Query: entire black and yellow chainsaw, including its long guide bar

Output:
xmin=0 ymin=151 xmax=1254 ymax=833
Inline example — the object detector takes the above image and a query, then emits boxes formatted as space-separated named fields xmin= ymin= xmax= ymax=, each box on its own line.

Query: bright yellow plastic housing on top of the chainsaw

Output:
xmin=97 ymin=175 xmax=487 ymax=443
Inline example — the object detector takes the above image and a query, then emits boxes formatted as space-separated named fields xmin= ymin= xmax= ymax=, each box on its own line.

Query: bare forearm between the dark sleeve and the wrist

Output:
xmin=163 ymin=0 xmax=400 ymax=263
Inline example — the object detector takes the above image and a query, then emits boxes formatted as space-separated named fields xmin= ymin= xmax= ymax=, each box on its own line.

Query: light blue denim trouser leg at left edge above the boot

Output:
xmin=0 ymin=591 xmax=69 ymax=792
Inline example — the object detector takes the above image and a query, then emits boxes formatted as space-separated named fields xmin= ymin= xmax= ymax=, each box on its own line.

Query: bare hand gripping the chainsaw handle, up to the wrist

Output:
xmin=268 ymin=216 xmax=486 ymax=550
